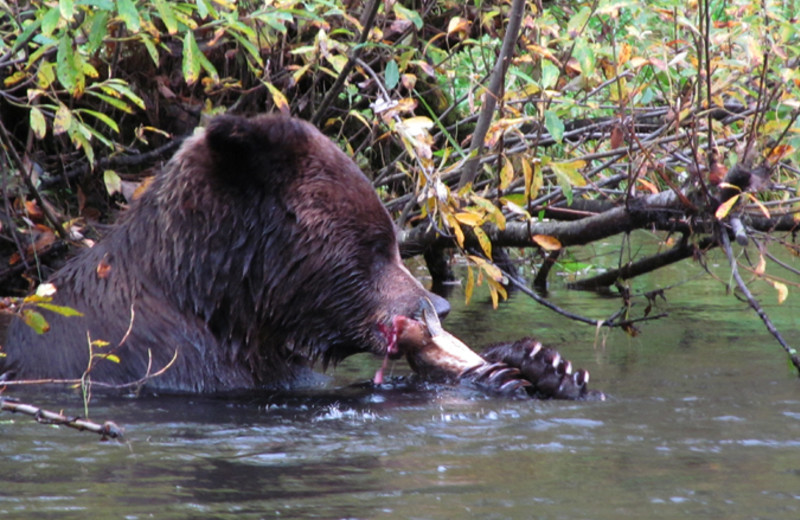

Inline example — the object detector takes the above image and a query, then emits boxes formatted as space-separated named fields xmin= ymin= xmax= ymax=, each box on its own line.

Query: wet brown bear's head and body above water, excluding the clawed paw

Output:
xmin=0 ymin=112 xmax=456 ymax=392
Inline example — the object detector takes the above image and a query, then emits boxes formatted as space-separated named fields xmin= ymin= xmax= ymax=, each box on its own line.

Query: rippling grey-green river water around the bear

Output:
xmin=0 ymin=238 xmax=800 ymax=520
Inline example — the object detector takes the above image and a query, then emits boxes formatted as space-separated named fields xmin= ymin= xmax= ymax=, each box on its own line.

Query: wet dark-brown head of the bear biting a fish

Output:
xmin=140 ymin=116 xmax=449 ymax=381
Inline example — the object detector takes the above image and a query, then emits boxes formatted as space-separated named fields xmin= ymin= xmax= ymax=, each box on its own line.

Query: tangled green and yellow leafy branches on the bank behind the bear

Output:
xmin=0 ymin=0 xmax=800 ymax=370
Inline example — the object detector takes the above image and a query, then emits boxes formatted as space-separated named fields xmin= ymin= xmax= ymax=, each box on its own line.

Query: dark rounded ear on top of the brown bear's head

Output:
xmin=206 ymin=115 xmax=314 ymax=176
